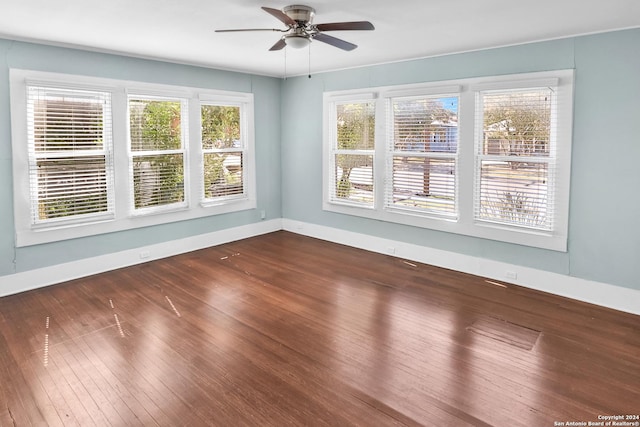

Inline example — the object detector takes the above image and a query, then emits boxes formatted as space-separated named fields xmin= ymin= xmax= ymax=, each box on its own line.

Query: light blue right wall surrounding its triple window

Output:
xmin=282 ymin=29 xmax=640 ymax=289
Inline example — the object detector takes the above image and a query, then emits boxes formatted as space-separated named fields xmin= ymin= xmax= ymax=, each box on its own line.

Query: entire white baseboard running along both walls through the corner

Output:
xmin=0 ymin=219 xmax=640 ymax=315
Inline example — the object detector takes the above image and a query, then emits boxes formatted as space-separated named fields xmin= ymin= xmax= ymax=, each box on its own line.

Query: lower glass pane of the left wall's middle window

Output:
xmin=133 ymin=153 xmax=185 ymax=209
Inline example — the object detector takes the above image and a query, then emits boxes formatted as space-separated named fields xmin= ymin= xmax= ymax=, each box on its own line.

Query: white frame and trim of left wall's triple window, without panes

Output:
xmin=10 ymin=69 xmax=257 ymax=247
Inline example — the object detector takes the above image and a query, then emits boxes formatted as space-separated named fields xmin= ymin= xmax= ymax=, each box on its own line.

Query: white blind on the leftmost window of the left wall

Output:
xmin=27 ymin=85 xmax=114 ymax=226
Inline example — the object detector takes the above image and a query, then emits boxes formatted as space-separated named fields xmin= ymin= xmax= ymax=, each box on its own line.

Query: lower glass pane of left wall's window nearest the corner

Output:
xmin=204 ymin=151 xmax=244 ymax=199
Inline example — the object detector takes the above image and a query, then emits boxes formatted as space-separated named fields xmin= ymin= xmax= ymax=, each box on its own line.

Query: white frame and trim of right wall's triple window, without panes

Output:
xmin=323 ymin=70 xmax=574 ymax=252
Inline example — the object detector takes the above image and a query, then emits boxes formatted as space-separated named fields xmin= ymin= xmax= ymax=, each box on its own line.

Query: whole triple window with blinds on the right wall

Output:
xmin=323 ymin=70 xmax=573 ymax=251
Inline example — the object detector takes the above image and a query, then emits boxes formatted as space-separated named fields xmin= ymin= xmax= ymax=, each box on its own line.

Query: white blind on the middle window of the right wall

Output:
xmin=385 ymin=96 xmax=459 ymax=217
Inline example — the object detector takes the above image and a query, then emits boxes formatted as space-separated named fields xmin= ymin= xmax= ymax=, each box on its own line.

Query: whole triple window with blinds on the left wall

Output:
xmin=10 ymin=70 xmax=256 ymax=246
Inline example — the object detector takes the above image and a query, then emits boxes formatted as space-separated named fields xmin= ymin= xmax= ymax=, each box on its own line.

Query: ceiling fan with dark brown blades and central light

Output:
xmin=216 ymin=4 xmax=375 ymax=51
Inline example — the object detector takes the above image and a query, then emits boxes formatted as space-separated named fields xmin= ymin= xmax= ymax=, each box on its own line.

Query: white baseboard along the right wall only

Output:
xmin=283 ymin=219 xmax=640 ymax=315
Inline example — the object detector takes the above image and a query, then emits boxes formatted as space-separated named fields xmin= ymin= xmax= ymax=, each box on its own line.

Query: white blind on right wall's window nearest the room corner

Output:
xmin=329 ymin=100 xmax=375 ymax=207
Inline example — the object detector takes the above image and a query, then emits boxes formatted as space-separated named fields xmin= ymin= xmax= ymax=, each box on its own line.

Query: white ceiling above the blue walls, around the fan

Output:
xmin=0 ymin=0 xmax=640 ymax=76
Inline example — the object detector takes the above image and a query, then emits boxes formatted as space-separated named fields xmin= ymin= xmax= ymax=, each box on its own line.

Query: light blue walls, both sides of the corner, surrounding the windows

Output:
xmin=0 ymin=29 xmax=640 ymax=289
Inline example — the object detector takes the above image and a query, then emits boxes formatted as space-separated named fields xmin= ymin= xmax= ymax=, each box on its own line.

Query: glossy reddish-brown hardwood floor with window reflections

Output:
xmin=0 ymin=232 xmax=640 ymax=426
